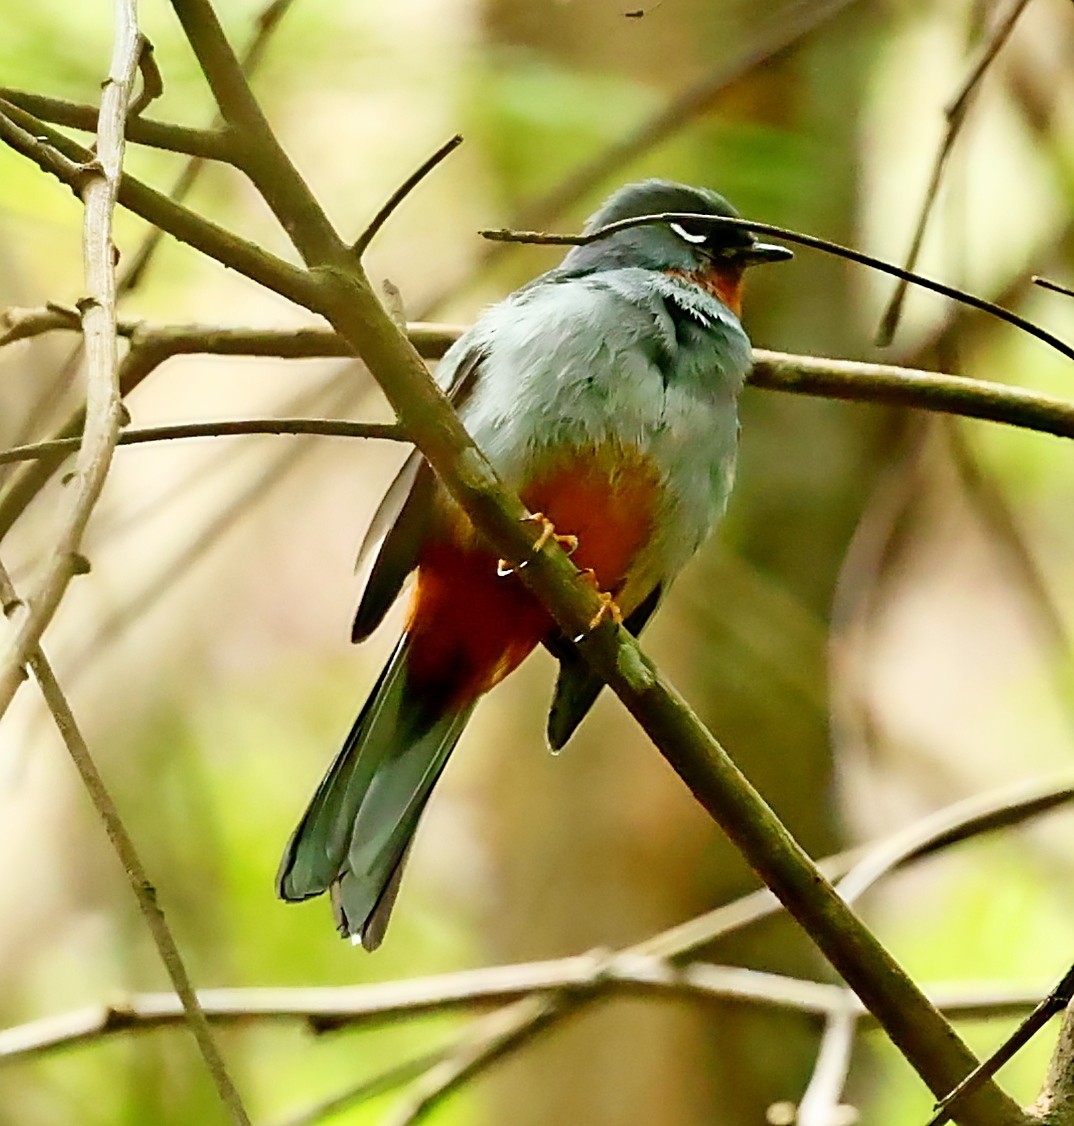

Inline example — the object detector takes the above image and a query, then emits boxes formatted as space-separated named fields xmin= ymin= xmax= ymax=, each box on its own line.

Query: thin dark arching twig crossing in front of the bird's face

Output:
xmin=480 ymin=212 xmax=1074 ymax=359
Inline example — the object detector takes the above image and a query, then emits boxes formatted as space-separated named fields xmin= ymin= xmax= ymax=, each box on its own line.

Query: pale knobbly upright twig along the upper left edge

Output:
xmin=0 ymin=0 xmax=142 ymax=716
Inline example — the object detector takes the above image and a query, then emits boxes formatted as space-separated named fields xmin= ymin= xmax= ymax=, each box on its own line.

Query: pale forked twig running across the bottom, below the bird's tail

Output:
xmin=0 ymin=770 xmax=1058 ymax=1103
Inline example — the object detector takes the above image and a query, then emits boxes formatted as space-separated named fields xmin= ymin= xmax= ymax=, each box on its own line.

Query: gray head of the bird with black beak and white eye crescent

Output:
xmin=562 ymin=180 xmax=791 ymax=274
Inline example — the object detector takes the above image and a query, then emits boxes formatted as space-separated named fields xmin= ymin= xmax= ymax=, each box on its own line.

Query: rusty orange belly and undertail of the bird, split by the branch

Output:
xmin=409 ymin=452 xmax=660 ymax=705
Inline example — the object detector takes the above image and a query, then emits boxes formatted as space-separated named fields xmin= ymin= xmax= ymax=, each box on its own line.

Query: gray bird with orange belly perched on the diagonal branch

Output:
xmin=277 ymin=179 xmax=791 ymax=950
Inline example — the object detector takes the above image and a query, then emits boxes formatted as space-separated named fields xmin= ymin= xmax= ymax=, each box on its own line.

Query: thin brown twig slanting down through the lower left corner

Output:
xmin=0 ymin=564 xmax=250 ymax=1126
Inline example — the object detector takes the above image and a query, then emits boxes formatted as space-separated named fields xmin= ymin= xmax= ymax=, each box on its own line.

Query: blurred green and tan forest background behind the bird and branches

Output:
xmin=0 ymin=0 xmax=1074 ymax=1126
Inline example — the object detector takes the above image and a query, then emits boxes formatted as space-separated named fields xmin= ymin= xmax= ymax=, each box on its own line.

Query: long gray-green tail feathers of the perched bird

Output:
xmin=276 ymin=635 xmax=473 ymax=950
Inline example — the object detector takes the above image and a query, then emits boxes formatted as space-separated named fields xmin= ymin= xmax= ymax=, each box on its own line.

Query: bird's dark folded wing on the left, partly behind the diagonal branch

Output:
xmin=351 ymin=348 xmax=484 ymax=642
